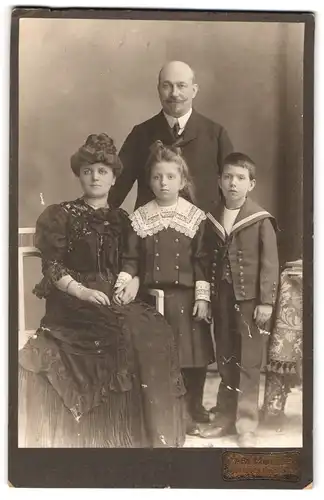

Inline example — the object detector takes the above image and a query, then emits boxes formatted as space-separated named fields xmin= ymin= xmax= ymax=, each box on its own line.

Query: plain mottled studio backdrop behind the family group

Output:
xmin=19 ymin=19 xmax=304 ymax=327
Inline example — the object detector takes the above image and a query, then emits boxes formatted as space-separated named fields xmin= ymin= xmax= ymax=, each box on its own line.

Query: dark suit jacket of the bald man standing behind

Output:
xmin=109 ymin=110 xmax=233 ymax=211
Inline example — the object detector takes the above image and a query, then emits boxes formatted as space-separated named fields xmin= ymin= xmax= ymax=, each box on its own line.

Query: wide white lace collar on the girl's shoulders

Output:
xmin=129 ymin=198 xmax=206 ymax=238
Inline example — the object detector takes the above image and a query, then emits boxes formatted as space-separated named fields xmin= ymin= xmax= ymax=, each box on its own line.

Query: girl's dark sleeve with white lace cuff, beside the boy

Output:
xmin=193 ymin=220 xmax=210 ymax=301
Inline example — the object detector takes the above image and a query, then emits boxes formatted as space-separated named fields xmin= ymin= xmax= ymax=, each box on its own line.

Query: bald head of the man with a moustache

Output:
xmin=158 ymin=61 xmax=198 ymax=118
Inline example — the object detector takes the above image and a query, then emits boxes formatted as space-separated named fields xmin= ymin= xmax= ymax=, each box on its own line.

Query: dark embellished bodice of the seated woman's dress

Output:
xmin=35 ymin=198 xmax=129 ymax=297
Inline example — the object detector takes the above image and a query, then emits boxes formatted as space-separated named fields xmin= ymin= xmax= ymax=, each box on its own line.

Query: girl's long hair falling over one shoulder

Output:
xmin=145 ymin=141 xmax=195 ymax=203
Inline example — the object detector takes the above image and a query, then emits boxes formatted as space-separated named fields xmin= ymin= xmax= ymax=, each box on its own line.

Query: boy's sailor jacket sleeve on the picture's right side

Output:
xmin=260 ymin=219 xmax=279 ymax=305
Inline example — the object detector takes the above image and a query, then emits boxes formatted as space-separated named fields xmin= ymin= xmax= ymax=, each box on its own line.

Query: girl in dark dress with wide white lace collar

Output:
xmin=115 ymin=141 xmax=214 ymax=435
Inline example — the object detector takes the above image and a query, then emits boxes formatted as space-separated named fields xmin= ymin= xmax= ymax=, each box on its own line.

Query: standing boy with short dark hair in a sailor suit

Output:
xmin=201 ymin=153 xmax=279 ymax=447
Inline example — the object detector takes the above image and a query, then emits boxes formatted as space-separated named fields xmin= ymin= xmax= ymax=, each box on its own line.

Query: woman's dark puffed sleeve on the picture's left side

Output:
xmin=34 ymin=205 xmax=69 ymax=297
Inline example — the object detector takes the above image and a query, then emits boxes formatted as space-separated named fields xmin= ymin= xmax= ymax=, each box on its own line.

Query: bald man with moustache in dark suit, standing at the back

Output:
xmin=109 ymin=61 xmax=233 ymax=211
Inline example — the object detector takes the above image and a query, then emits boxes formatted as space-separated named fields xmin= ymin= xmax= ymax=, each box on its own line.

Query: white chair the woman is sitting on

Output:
xmin=18 ymin=227 xmax=164 ymax=348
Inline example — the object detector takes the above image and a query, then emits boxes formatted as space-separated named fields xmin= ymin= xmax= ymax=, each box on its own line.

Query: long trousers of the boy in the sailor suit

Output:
xmin=212 ymin=280 xmax=265 ymax=434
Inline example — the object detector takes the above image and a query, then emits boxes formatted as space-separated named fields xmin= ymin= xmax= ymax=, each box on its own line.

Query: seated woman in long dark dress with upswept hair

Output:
xmin=19 ymin=134 xmax=185 ymax=448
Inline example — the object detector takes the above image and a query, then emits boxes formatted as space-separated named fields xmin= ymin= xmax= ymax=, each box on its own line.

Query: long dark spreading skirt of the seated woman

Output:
xmin=19 ymin=292 xmax=185 ymax=448
